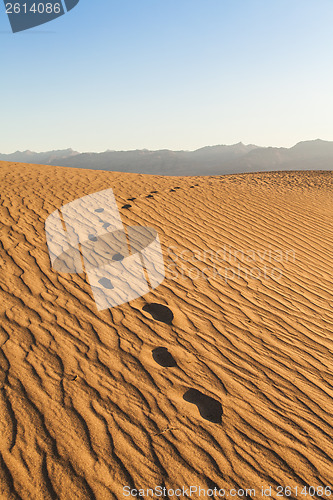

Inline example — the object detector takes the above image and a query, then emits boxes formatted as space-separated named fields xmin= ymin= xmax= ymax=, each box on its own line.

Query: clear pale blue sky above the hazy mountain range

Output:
xmin=0 ymin=0 xmax=333 ymax=153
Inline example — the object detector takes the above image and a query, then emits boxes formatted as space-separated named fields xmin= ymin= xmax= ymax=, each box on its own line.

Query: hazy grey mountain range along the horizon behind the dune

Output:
xmin=0 ymin=139 xmax=333 ymax=175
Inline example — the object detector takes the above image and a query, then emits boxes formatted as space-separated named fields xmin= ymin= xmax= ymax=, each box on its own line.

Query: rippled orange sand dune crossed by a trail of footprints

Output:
xmin=0 ymin=162 xmax=333 ymax=500
